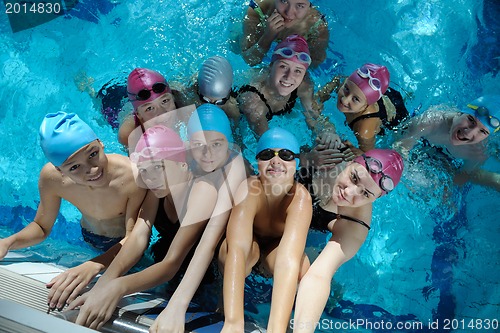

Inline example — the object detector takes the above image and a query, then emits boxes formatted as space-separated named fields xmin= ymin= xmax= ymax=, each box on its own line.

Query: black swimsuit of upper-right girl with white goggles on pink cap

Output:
xmin=348 ymin=88 xmax=409 ymax=135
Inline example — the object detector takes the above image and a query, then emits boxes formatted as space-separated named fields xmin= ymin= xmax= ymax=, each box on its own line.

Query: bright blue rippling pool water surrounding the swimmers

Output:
xmin=0 ymin=0 xmax=500 ymax=332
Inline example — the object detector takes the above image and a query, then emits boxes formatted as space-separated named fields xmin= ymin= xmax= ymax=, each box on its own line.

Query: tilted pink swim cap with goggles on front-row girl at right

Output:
xmin=354 ymin=149 xmax=404 ymax=195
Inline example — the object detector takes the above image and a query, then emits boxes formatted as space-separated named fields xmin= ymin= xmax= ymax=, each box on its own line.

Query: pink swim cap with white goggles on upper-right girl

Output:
xmin=349 ymin=63 xmax=389 ymax=105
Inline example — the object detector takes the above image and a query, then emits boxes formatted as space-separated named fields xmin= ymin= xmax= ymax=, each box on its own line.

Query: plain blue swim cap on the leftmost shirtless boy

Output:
xmin=39 ymin=111 xmax=97 ymax=167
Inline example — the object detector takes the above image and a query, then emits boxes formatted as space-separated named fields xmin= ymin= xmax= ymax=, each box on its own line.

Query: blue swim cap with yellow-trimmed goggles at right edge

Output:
xmin=462 ymin=95 xmax=500 ymax=134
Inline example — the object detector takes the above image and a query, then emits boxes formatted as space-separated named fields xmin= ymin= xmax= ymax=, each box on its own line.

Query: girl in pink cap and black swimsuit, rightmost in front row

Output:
xmin=293 ymin=149 xmax=404 ymax=332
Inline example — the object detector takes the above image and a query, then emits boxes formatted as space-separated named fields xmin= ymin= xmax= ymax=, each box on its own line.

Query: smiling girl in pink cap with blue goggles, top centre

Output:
xmin=238 ymin=35 xmax=334 ymax=143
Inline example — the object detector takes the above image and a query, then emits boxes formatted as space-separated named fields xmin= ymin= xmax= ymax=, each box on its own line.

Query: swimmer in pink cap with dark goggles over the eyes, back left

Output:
xmin=118 ymin=68 xmax=179 ymax=146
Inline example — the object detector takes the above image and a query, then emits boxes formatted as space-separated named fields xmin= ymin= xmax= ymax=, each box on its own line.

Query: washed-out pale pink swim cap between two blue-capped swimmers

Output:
xmin=130 ymin=125 xmax=186 ymax=163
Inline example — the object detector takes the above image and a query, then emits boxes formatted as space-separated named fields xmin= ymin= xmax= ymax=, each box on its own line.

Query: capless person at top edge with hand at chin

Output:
xmin=240 ymin=0 xmax=330 ymax=67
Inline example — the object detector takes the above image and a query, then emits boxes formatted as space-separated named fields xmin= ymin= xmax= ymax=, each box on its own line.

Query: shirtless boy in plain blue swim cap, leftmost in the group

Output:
xmin=0 ymin=112 xmax=145 ymax=309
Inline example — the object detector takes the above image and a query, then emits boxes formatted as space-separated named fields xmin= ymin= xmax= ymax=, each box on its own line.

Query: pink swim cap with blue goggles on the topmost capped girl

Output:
xmin=271 ymin=35 xmax=311 ymax=69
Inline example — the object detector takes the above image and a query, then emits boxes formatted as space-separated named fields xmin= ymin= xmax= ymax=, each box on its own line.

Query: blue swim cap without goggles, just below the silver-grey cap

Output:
xmin=187 ymin=103 xmax=233 ymax=142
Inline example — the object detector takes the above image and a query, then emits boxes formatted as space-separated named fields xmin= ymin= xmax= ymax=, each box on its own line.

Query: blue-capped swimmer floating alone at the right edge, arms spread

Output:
xmin=394 ymin=95 xmax=500 ymax=190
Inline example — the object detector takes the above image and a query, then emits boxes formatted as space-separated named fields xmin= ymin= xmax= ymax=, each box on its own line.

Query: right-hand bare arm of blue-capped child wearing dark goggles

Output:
xmin=267 ymin=184 xmax=312 ymax=332
